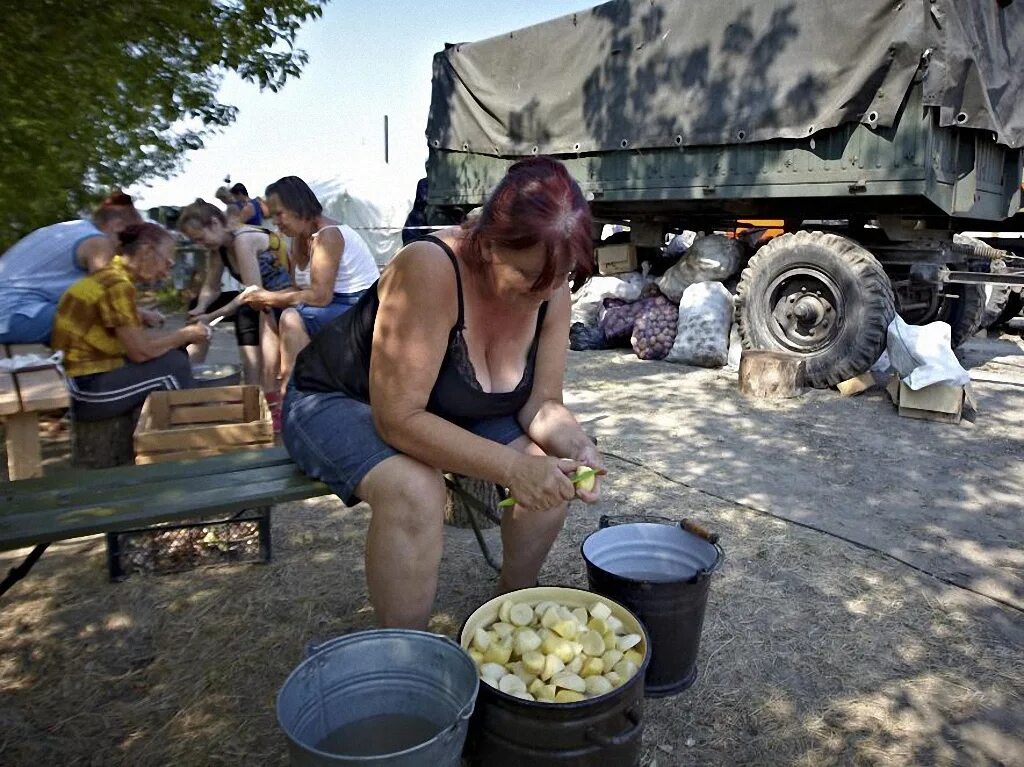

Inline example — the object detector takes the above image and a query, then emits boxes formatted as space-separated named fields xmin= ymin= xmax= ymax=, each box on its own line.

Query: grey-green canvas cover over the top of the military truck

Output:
xmin=427 ymin=0 xmax=1024 ymax=157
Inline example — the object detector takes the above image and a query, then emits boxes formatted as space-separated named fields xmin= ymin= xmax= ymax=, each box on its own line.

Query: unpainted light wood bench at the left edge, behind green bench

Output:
xmin=0 ymin=344 xmax=71 ymax=480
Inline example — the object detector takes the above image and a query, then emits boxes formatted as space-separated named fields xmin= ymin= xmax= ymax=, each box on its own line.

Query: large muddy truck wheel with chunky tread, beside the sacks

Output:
xmin=737 ymin=231 xmax=896 ymax=388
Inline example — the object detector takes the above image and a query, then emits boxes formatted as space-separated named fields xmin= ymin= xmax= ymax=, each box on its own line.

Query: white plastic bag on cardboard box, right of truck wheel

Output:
xmin=886 ymin=315 xmax=971 ymax=391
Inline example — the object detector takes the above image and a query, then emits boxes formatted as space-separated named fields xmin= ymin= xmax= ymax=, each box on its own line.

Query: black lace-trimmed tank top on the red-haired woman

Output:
xmin=293 ymin=237 xmax=548 ymax=425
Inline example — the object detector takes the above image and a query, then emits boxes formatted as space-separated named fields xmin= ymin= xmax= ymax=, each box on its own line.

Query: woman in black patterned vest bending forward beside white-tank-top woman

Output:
xmin=178 ymin=200 xmax=292 ymax=394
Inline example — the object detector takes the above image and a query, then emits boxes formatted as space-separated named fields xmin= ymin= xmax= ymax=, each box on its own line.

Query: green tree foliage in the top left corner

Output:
xmin=0 ymin=0 xmax=328 ymax=246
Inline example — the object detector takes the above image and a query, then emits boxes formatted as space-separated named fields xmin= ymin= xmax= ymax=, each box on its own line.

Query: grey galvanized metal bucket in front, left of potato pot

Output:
xmin=278 ymin=629 xmax=479 ymax=767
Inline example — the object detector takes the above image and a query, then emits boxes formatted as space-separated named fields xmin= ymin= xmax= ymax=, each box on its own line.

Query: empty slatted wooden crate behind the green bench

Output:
xmin=135 ymin=386 xmax=273 ymax=464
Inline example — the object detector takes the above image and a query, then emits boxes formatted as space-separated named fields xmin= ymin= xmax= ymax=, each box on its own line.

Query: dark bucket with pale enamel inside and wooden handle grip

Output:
xmin=582 ymin=517 xmax=724 ymax=697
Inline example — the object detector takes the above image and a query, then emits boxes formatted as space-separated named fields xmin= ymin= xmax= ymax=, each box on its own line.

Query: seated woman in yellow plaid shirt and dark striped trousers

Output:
xmin=52 ymin=223 xmax=210 ymax=421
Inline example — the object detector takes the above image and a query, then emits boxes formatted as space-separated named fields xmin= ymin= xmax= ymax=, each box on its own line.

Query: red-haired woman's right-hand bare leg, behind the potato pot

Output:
xmin=498 ymin=436 xmax=568 ymax=594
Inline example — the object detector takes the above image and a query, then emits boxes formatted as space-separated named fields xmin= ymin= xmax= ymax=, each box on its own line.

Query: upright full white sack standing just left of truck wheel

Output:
xmin=666 ymin=282 xmax=732 ymax=368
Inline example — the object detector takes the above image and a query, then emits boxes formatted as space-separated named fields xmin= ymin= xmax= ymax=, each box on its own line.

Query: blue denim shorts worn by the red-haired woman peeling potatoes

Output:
xmin=282 ymin=385 xmax=525 ymax=506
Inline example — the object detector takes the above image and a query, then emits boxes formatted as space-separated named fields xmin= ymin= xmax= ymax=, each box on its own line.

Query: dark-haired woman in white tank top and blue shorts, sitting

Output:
xmin=242 ymin=176 xmax=380 ymax=401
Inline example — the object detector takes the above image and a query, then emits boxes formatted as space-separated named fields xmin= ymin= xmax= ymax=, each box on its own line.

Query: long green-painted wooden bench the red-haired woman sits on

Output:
xmin=0 ymin=448 xmax=500 ymax=594
